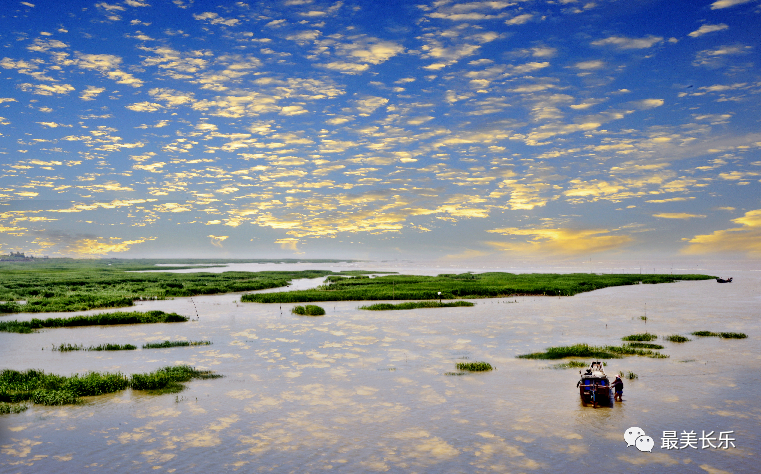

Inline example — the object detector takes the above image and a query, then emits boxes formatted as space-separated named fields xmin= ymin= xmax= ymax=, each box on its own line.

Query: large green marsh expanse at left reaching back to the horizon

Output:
xmin=0 ymin=258 xmax=366 ymax=313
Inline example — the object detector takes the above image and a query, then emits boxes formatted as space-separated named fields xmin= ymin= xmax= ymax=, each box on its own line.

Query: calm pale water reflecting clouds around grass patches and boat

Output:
xmin=0 ymin=263 xmax=761 ymax=473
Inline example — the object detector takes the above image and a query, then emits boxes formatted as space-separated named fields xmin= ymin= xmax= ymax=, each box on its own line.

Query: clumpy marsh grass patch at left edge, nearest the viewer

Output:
xmin=0 ymin=365 xmax=221 ymax=405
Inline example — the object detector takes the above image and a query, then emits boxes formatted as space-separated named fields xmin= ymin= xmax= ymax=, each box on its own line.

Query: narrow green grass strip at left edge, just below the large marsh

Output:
xmin=0 ymin=311 xmax=188 ymax=334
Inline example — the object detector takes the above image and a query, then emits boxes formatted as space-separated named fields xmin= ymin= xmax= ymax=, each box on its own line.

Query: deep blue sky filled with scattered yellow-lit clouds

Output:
xmin=0 ymin=0 xmax=761 ymax=262
